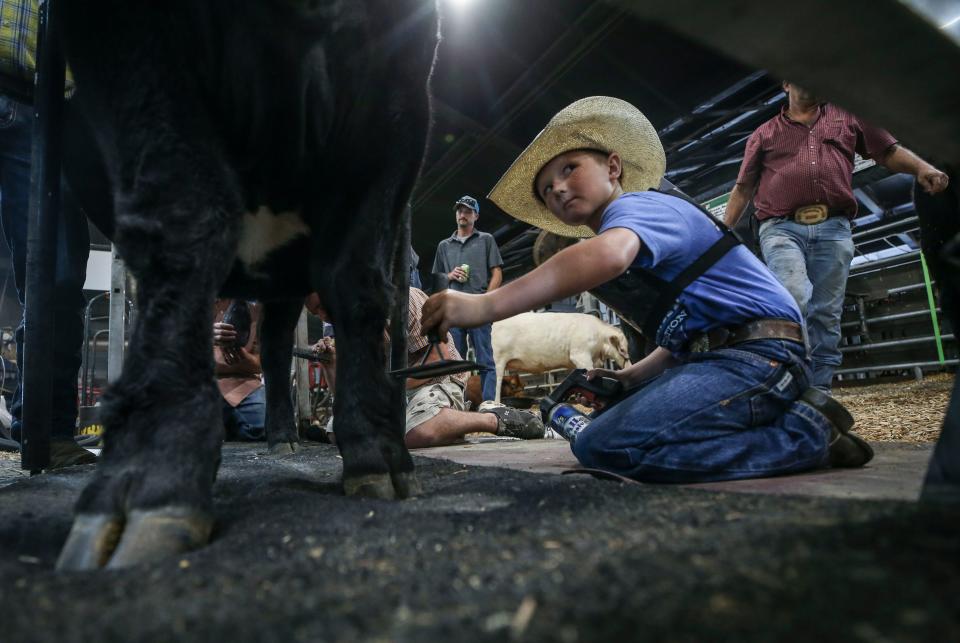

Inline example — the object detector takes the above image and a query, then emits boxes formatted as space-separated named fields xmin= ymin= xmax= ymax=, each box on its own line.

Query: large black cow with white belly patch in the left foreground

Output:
xmin=58 ymin=0 xmax=438 ymax=569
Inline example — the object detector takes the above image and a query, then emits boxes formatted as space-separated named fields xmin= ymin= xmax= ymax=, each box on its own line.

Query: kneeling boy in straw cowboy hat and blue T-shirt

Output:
xmin=423 ymin=96 xmax=873 ymax=482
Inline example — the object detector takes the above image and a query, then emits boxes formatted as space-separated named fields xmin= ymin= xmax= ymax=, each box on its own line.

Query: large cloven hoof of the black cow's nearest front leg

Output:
xmin=57 ymin=507 xmax=213 ymax=571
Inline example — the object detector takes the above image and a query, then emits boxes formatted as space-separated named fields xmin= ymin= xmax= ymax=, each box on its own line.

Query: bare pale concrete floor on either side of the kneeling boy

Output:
xmin=414 ymin=438 xmax=933 ymax=500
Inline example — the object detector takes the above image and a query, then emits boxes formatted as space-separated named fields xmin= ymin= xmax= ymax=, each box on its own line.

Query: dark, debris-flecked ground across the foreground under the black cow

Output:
xmin=0 ymin=445 xmax=960 ymax=643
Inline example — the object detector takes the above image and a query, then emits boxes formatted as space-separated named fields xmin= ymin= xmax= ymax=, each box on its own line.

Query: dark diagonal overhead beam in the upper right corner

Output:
xmin=607 ymin=0 xmax=960 ymax=169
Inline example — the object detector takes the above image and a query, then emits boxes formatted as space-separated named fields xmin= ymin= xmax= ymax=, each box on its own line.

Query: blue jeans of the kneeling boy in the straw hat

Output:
xmin=572 ymin=339 xmax=830 ymax=482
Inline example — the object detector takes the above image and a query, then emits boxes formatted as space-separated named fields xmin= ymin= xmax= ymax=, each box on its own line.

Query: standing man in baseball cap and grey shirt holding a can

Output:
xmin=433 ymin=195 xmax=503 ymax=400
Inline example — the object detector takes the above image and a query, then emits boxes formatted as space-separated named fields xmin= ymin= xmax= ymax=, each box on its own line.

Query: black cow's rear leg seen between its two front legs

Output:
xmin=260 ymin=299 xmax=303 ymax=455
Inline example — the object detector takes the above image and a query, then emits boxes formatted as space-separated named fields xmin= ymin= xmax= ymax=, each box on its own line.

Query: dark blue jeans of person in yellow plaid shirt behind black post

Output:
xmin=0 ymin=95 xmax=90 ymax=441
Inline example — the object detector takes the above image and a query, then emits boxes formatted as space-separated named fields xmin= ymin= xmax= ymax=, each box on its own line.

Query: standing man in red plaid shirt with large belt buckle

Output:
xmin=724 ymin=81 xmax=948 ymax=393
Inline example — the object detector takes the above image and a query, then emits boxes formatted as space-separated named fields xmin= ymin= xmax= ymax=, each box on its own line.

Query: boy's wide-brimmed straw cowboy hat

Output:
xmin=487 ymin=96 xmax=667 ymax=238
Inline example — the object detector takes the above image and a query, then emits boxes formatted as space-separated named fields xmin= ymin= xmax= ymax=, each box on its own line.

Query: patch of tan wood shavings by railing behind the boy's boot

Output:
xmin=833 ymin=373 xmax=954 ymax=442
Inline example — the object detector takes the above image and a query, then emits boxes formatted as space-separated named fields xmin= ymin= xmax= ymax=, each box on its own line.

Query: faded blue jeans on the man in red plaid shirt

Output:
xmin=760 ymin=217 xmax=853 ymax=392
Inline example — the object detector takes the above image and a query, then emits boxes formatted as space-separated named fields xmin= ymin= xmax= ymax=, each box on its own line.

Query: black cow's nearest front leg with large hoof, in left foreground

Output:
xmin=57 ymin=140 xmax=239 ymax=569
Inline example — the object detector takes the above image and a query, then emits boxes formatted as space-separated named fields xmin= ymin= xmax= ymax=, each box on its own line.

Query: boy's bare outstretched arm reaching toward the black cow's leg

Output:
xmin=423 ymin=228 xmax=640 ymax=337
